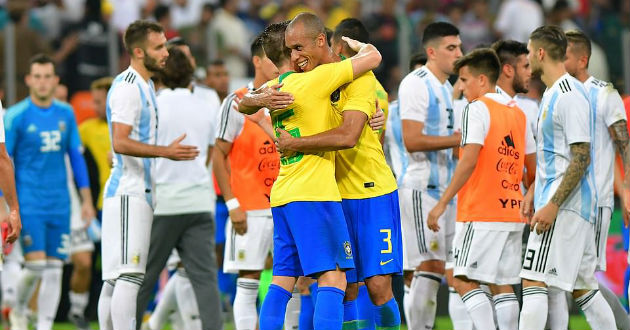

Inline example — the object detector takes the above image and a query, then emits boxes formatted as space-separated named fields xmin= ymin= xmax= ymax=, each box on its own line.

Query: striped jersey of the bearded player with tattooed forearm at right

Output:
xmin=535 ymin=73 xmax=597 ymax=221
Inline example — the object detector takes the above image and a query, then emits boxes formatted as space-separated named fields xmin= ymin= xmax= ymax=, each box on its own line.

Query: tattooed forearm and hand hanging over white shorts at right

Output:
xmin=530 ymin=142 xmax=591 ymax=234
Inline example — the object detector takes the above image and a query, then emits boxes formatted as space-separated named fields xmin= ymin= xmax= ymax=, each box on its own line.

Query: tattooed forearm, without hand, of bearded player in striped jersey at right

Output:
xmin=551 ymin=142 xmax=591 ymax=207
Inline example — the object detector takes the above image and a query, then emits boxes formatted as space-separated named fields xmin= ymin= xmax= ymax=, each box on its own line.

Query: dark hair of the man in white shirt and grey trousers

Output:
xmin=157 ymin=46 xmax=195 ymax=89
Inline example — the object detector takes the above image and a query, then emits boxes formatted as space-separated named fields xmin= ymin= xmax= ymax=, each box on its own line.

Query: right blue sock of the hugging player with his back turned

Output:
xmin=314 ymin=287 xmax=346 ymax=330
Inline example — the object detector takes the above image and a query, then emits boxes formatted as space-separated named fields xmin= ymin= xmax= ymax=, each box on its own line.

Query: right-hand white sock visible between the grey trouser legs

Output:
xmin=173 ymin=268 xmax=201 ymax=330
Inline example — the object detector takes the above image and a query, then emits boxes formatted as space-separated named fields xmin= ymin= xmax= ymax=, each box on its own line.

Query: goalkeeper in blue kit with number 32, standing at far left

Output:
xmin=5 ymin=55 xmax=95 ymax=330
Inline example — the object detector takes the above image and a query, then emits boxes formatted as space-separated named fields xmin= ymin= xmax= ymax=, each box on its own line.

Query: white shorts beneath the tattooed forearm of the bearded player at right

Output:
xmin=521 ymin=210 xmax=598 ymax=292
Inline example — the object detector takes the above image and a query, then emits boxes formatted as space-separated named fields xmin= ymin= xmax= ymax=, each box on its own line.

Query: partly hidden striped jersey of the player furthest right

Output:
xmin=584 ymin=76 xmax=626 ymax=207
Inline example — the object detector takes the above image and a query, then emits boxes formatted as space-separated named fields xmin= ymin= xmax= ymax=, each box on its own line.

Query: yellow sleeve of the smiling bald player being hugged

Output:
xmin=341 ymin=72 xmax=376 ymax=119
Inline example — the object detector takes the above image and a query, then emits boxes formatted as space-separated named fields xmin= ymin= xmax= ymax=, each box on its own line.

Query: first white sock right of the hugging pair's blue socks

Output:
xmin=409 ymin=271 xmax=443 ymax=329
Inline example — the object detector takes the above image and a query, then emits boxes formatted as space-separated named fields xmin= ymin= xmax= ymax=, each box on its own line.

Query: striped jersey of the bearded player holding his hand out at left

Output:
xmin=104 ymin=67 xmax=157 ymax=205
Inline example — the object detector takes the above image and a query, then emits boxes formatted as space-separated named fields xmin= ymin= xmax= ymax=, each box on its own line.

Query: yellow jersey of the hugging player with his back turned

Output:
xmin=267 ymin=60 xmax=353 ymax=207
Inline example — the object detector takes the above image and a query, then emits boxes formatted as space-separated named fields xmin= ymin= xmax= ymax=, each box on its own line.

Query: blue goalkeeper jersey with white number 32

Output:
xmin=5 ymin=98 xmax=80 ymax=213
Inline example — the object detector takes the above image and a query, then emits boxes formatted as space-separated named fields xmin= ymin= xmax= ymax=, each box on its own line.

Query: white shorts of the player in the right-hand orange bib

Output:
xmin=453 ymin=222 xmax=525 ymax=285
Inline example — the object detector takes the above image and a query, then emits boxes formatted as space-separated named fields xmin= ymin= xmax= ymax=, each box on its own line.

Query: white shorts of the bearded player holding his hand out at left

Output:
xmin=101 ymin=195 xmax=153 ymax=280
